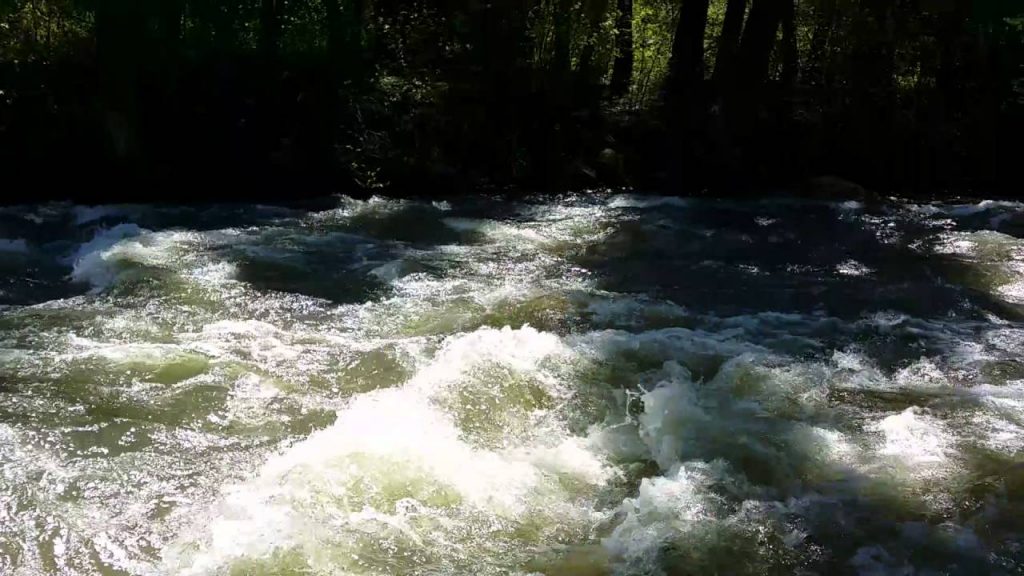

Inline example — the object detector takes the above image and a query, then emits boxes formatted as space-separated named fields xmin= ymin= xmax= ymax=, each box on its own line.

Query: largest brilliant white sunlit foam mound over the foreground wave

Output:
xmin=167 ymin=328 xmax=614 ymax=574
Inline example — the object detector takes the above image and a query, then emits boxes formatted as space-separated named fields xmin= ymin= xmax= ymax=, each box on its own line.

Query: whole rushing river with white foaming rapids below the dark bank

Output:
xmin=0 ymin=194 xmax=1024 ymax=576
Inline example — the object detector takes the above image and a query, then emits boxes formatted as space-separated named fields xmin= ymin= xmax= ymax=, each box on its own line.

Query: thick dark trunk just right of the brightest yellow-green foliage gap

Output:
xmin=668 ymin=0 xmax=710 ymax=100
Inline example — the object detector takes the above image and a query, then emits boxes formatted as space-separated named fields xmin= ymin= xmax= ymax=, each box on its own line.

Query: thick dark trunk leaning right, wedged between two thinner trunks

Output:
xmin=736 ymin=0 xmax=793 ymax=89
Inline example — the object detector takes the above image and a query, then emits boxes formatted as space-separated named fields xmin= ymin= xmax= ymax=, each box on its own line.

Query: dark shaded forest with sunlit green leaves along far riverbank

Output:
xmin=0 ymin=0 xmax=1024 ymax=200
